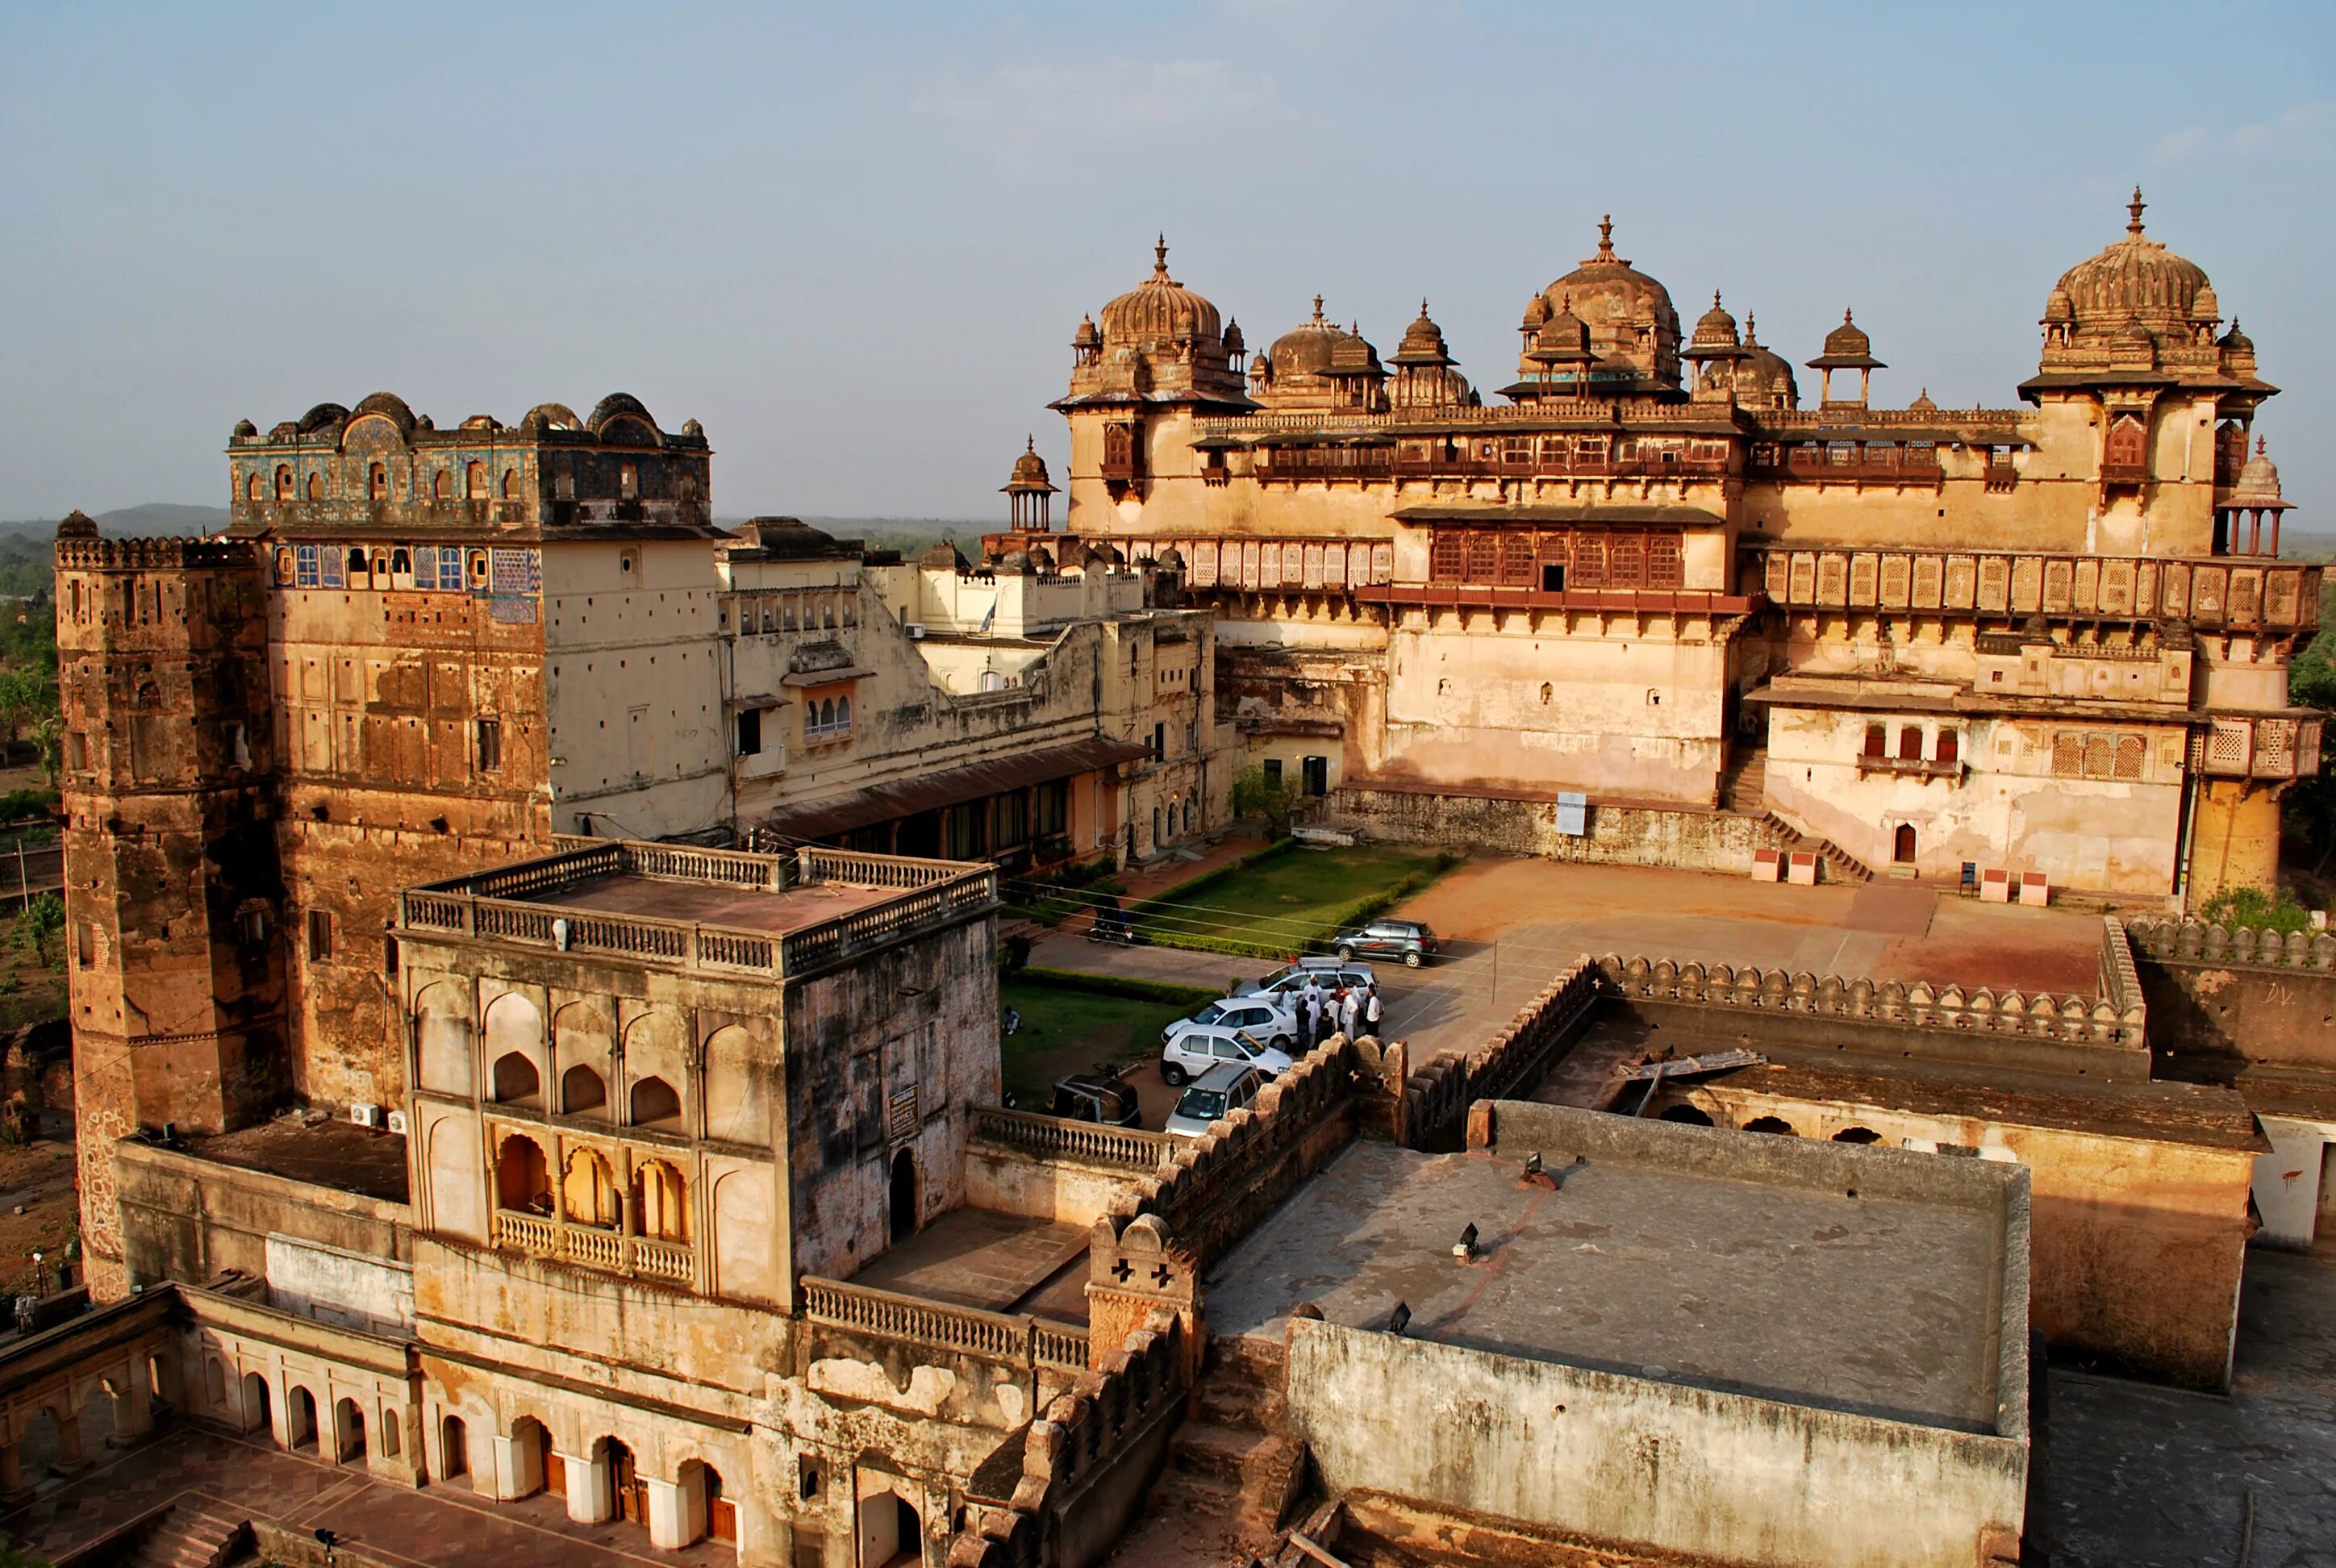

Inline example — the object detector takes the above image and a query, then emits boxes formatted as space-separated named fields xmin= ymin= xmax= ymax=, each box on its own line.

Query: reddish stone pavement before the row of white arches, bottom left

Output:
xmin=0 ymin=1423 xmax=738 ymax=1568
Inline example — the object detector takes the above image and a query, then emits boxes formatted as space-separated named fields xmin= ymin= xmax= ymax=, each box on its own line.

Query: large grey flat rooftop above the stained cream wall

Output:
xmin=1208 ymin=1128 xmax=2004 ymax=1430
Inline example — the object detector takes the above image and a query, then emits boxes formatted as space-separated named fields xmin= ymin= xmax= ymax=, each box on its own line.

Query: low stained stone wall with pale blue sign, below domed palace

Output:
xmin=1332 ymin=785 xmax=1789 ymax=876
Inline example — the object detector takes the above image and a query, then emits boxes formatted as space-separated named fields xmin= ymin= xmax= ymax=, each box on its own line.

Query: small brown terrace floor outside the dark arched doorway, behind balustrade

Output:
xmin=850 ymin=1208 xmax=1089 ymax=1325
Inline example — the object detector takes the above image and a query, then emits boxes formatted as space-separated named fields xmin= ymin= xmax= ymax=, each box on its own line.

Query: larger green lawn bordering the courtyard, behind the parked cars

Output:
xmin=1128 ymin=839 xmax=1460 ymax=958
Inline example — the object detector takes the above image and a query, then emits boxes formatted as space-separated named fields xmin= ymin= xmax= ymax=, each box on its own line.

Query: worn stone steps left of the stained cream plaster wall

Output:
xmin=1145 ymin=1337 xmax=1306 ymax=1561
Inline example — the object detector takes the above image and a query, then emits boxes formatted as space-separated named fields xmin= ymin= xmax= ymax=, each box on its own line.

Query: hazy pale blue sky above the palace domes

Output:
xmin=0 ymin=0 xmax=2336 ymax=526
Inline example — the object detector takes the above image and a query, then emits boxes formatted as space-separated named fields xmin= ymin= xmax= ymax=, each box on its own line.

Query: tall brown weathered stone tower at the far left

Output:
xmin=56 ymin=511 xmax=290 ymax=1299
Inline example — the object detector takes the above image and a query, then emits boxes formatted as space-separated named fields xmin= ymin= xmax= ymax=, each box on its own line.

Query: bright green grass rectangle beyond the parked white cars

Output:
xmin=1140 ymin=844 xmax=1453 ymax=951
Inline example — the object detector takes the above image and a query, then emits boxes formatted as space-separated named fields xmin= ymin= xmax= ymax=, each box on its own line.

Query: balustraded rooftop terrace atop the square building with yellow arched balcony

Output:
xmin=397 ymin=839 xmax=998 ymax=979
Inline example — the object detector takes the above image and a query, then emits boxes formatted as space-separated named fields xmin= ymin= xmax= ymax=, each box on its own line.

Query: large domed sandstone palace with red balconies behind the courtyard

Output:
xmin=988 ymin=192 xmax=2320 ymax=907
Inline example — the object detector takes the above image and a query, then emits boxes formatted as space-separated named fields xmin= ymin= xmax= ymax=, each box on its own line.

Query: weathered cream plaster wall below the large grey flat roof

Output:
xmin=1290 ymin=1320 xmax=2028 ymax=1568
